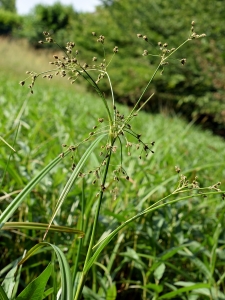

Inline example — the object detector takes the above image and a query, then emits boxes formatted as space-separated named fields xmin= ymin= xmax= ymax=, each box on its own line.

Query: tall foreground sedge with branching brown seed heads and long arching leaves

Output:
xmin=0 ymin=22 xmax=224 ymax=300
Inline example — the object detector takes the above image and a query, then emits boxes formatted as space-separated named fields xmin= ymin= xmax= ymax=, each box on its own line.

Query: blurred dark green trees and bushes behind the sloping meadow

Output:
xmin=4 ymin=0 xmax=225 ymax=136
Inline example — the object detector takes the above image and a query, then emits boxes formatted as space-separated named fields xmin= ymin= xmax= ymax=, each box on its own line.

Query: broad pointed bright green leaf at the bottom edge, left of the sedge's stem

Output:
xmin=16 ymin=263 xmax=52 ymax=300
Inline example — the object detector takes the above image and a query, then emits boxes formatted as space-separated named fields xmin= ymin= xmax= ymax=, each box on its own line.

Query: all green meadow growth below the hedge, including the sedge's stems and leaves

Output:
xmin=0 ymin=18 xmax=225 ymax=300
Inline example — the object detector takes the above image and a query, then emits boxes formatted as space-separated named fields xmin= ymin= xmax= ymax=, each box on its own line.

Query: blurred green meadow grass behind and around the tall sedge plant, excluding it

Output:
xmin=0 ymin=35 xmax=225 ymax=299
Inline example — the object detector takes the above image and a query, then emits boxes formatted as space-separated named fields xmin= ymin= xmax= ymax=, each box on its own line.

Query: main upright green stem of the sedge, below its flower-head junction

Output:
xmin=74 ymin=146 xmax=114 ymax=300
